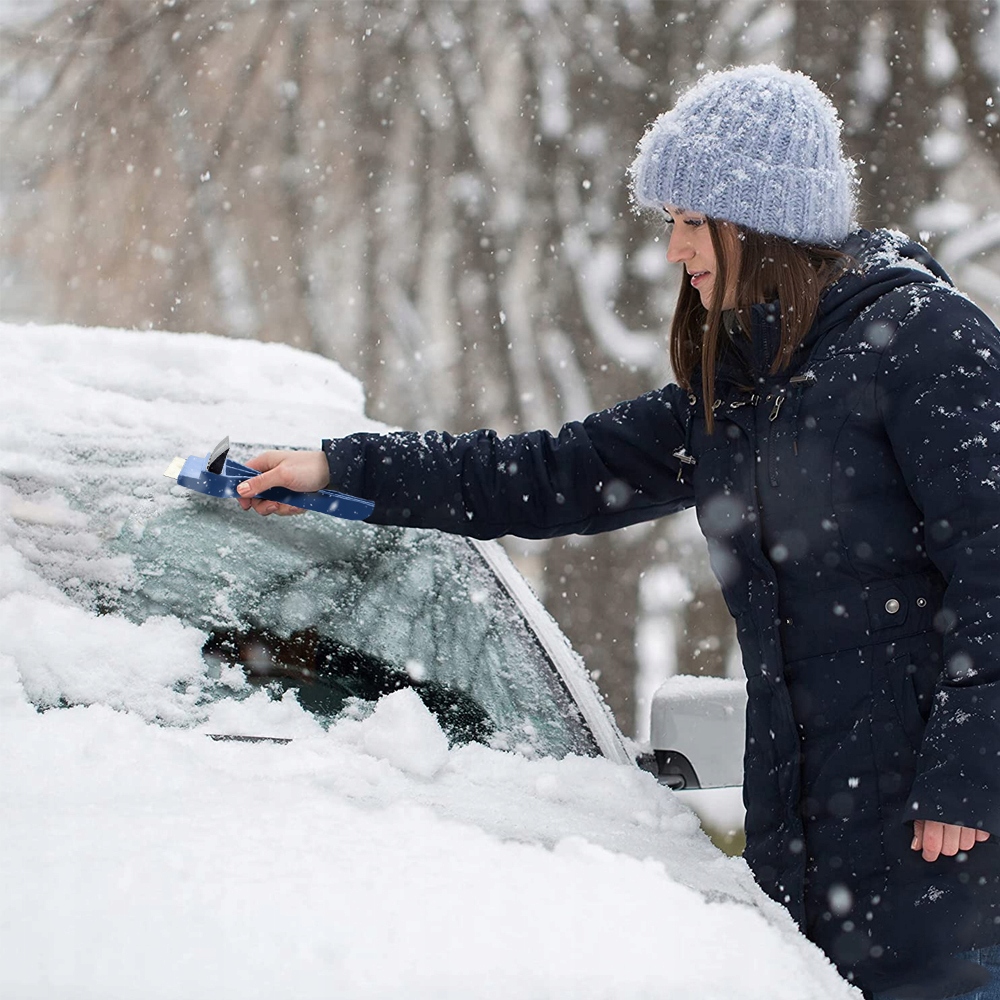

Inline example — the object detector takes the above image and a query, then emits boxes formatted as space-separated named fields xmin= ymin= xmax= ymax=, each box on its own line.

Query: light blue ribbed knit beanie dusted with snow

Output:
xmin=630 ymin=65 xmax=854 ymax=245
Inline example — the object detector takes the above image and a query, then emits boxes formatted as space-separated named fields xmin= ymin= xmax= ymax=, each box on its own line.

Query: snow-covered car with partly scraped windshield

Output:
xmin=0 ymin=326 xmax=857 ymax=1000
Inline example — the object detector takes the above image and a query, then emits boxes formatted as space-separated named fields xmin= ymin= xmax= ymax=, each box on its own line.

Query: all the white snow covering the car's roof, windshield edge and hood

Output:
xmin=0 ymin=326 xmax=859 ymax=1000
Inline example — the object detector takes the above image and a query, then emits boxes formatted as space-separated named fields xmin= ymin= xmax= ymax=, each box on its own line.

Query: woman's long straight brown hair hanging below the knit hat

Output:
xmin=670 ymin=218 xmax=852 ymax=433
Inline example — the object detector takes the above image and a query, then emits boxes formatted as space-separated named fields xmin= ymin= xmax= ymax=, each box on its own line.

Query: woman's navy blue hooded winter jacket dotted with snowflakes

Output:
xmin=324 ymin=231 xmax=1000 ymax=996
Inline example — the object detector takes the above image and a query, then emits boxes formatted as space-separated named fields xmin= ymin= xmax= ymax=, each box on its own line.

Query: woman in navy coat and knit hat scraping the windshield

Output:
xmin=241 ymin=66 xmax=1000 ymax=997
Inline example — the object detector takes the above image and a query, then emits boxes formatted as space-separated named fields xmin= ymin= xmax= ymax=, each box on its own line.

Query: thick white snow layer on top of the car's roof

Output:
xmin=0 ymin=323 xmax=380 ymax=459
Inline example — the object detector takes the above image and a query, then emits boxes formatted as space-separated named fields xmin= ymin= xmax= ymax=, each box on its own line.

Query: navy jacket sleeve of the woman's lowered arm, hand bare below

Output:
xmin=877 ymin=286 xmax=1000 ymax=835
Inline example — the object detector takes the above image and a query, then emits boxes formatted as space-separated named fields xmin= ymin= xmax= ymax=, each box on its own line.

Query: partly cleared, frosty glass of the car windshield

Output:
xmin=105 ymin=494 xmax=597 ymax=756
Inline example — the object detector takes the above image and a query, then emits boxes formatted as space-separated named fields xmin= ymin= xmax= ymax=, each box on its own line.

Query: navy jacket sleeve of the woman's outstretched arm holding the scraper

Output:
xmin=323 ymin=386 xmax=693 ymax=538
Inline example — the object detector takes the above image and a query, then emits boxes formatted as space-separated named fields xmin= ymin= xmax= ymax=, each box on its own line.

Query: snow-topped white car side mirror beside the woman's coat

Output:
xmin=639 ymin=674 xmax=747 ymax=789
